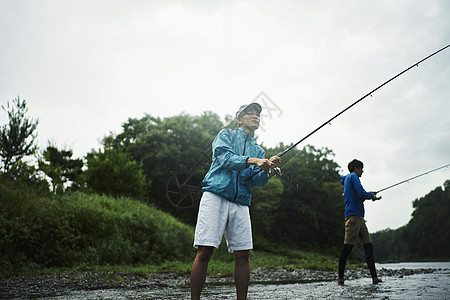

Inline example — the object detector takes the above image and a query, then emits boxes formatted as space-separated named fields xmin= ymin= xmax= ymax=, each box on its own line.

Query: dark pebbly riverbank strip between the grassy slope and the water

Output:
xmin=0 ymin=268 xmax=438 ymax=299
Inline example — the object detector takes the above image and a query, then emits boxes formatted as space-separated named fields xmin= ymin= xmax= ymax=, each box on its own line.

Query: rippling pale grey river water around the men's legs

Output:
xmin=29 ymin=262 xmax=450 ymax=300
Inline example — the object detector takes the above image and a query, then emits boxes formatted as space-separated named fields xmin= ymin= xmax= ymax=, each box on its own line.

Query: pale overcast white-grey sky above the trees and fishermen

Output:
xmin=0 ymin=0 xmax=450 ymax=232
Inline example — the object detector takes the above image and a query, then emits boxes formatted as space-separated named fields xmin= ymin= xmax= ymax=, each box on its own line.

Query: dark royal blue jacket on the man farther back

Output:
xmin=341 ymin=173 xmax=375 ymax=218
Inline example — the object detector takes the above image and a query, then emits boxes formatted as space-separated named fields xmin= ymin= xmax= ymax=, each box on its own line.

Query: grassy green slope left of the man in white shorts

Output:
xmin=0 ymin=189 xmax=193 ymax=272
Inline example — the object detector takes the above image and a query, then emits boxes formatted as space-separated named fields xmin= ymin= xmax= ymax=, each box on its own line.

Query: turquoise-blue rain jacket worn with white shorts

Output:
xmin=202 ymin=128 xmax=268 ymax=206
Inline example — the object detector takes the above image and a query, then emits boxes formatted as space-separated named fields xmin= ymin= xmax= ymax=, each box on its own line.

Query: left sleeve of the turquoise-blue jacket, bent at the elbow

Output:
xmin=212 ymin=129 xmax=248 ymax=171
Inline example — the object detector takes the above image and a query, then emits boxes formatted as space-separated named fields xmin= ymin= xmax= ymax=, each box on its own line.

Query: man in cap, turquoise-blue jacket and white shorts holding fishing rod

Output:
xmin=191 ymin=103 xmax=281 ymax=299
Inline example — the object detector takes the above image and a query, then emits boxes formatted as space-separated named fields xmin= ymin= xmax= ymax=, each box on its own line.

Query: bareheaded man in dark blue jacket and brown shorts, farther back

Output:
xmin=338 ymin=159 xmax=381 ymax=284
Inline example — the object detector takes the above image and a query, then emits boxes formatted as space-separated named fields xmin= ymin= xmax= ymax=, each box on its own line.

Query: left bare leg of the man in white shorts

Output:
xmin=191 ymin=246 xmax=214 ymax=300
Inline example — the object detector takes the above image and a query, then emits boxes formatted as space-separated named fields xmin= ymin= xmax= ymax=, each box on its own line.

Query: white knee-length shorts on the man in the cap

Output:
xmin=194 ymin=192 xmax=253 ymax=252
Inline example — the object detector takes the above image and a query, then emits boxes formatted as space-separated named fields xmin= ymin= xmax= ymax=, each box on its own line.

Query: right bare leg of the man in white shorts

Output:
xmin=234 ymin=250 xmax=250 ymax=300
